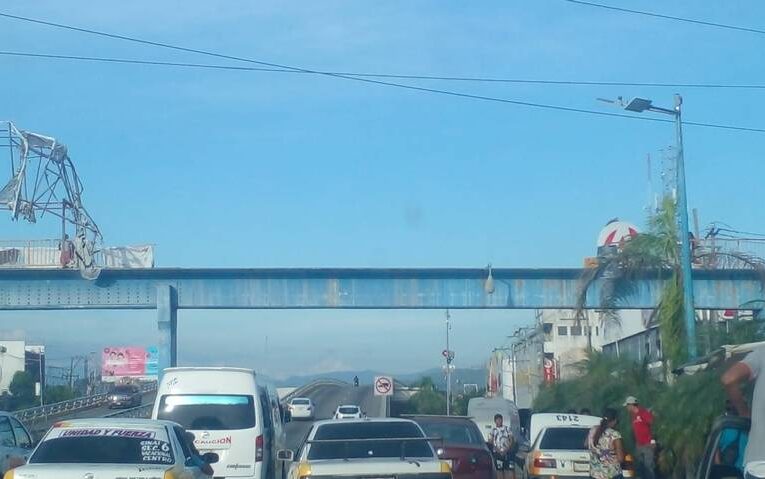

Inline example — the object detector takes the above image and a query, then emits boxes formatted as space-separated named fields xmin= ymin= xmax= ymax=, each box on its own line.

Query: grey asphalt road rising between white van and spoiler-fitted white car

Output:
xmin=285 ymin=385 xmax=386 ymax=450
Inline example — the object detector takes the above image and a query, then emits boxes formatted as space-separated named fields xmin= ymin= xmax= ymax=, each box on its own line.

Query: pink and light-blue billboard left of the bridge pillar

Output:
xmin=101 ymin=346 xmax=159 ymax=382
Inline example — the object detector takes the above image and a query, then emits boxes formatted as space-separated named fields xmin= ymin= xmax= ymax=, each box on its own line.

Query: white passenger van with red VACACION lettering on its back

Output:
xmin=151 ymin=367 xmax=285 ymax=479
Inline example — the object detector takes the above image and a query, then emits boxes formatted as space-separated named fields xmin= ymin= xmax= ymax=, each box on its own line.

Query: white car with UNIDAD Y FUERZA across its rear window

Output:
xmin=5 ymin=418 xmax=217 ymax=479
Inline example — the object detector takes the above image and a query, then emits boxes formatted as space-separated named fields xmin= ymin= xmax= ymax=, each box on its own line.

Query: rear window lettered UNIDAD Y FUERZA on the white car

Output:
xmin=29 ymin=428 xmax=175 ymax=464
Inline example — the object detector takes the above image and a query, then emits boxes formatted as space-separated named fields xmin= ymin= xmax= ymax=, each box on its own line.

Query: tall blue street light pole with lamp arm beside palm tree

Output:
xmin=606 ymin=94 xmax=697 ymax=359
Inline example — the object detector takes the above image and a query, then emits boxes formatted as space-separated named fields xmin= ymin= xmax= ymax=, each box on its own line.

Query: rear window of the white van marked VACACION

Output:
xmin=157 ymin=394 xmax=255 ymax=431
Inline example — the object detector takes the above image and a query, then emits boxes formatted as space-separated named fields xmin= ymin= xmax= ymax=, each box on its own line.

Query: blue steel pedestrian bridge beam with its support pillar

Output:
xmin=0 ymin=268 xmax=765 ymax=369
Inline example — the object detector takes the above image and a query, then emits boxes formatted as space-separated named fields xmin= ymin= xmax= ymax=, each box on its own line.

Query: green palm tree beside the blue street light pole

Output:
xmin=577 ymin=197 xmax=765 ymax=365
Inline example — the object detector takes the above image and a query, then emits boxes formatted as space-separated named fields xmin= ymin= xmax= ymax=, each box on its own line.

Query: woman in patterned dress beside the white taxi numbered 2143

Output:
xmin=587 ymin=408 xmax=624 ymax=479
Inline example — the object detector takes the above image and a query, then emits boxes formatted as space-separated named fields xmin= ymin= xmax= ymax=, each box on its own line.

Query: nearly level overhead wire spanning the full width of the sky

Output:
xmin=0 ymin=51 xmax=765 ymax=90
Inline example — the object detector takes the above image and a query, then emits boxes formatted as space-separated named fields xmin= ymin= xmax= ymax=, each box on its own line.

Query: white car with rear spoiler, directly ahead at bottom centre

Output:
xmin=279 ymin=418 xmax=452 ymax=479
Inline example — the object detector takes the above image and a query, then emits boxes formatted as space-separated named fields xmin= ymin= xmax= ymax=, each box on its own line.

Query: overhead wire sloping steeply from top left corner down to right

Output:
xmin=0 ymin=12 xmax=765 ymax=133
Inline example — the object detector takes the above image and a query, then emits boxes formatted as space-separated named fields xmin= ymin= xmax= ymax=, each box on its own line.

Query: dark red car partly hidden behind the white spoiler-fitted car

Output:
xmin=409 ymin=416 xmax=496 ymax=479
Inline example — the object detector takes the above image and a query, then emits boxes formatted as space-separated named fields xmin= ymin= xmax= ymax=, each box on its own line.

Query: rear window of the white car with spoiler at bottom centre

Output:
xmin=308 ymin=421 xmax=433 ymax=459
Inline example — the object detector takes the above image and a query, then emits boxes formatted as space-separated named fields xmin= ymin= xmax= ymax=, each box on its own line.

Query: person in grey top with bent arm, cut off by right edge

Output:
xmin=721 ymin=347 xmax=765 ymax=464
